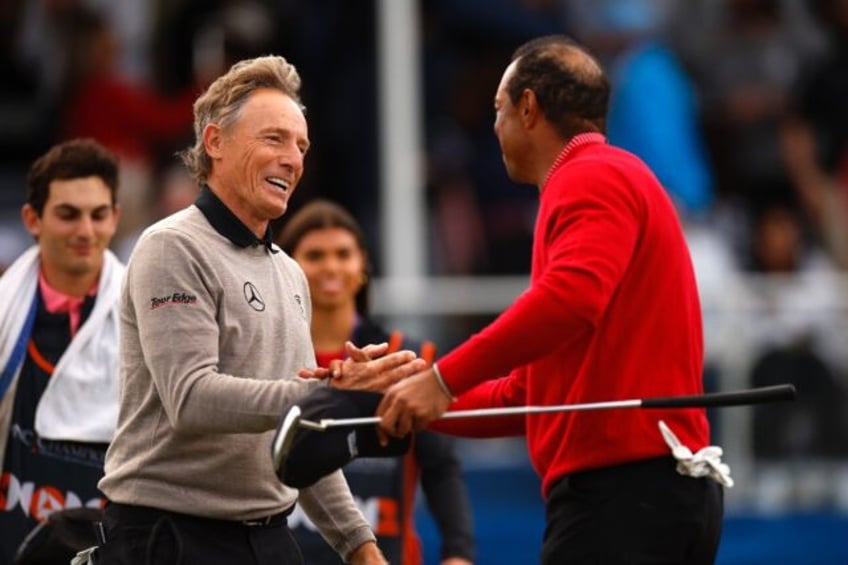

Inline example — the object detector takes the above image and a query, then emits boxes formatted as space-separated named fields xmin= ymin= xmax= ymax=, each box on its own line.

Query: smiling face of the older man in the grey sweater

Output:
xmin=204 ymin=88 xmax=309 ymax=237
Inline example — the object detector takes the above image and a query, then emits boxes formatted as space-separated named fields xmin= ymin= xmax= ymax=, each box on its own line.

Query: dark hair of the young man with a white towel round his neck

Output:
xmin=26 ymin=139 xmax=118 ymax=216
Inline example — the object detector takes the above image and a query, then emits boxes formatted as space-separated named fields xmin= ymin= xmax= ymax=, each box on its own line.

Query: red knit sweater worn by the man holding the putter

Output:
xmin=433 ymin=134 xmax=709 ymax=495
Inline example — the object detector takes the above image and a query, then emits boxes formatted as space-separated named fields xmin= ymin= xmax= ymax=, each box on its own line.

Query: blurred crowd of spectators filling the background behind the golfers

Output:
xmin=0 ymin=0 xmax=848 ymax=468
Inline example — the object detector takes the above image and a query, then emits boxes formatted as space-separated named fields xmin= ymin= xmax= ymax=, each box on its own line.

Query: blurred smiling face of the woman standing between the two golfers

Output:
xmin=292 ymin=227 xmax=366 ymax=310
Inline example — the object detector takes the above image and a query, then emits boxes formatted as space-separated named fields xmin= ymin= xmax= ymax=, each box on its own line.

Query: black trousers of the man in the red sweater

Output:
xmin=541 ymin=457 xmax=724 ymax=565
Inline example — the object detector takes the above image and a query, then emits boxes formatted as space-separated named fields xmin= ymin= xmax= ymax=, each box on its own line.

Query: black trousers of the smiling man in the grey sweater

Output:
xmin=96 ymin=503 xmax=303 ymax=565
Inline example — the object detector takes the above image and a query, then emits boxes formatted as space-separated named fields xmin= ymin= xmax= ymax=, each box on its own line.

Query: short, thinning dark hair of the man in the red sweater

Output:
xmin=506 ymin=35 xmax=610 ymax=138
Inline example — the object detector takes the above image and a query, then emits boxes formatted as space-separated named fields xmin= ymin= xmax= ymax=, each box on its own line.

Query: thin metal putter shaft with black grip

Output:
xmin=300 ymin=385 xmax=795 ymax=430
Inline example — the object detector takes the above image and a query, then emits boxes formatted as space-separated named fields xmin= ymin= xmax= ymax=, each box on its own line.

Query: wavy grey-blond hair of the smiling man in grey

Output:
xmin=179 ymin=55 xmax=303 ymax=184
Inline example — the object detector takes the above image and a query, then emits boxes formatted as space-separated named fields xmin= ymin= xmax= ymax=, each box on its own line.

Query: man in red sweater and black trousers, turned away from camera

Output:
xmin=377 ymin=36 xmax=723 ymax=564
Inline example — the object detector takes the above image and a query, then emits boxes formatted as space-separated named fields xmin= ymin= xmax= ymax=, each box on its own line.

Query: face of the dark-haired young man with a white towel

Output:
xmin=22 ymin=176 xmax=118 ymax=290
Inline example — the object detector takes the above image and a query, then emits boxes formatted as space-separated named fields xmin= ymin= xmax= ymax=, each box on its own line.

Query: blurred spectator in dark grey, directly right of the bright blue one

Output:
xmin=690 ymin=0 xmax=808 ymax=219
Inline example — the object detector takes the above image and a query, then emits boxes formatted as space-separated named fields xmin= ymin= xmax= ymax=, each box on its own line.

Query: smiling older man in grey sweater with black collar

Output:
xmin=99 ymin=56 xmax=423 ymax=565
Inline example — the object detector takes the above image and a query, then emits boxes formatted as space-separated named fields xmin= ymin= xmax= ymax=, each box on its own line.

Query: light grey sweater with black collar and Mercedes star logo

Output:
xmin=99 ymin=188 xmax=374 ymax=557
